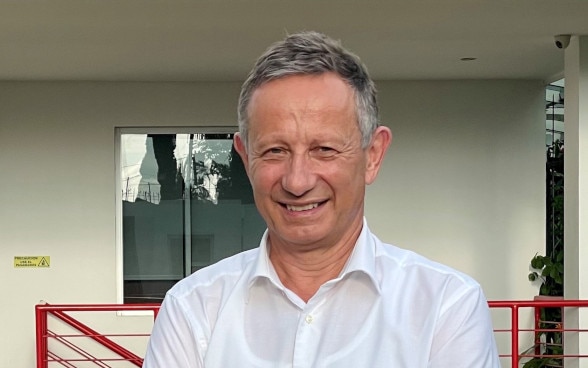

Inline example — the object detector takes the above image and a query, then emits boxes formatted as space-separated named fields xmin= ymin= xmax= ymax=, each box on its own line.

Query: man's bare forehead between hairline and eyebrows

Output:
xmin=243 ymin=74 xmax=361 ymax=146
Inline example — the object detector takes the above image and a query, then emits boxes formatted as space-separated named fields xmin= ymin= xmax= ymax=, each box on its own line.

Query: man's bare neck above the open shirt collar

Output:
xmin=268 ymin=226 xmax=361 ymax=302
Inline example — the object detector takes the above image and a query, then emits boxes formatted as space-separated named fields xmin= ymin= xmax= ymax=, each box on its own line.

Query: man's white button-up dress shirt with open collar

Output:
xmin=143 ymin=221 xmax=500 ymax=368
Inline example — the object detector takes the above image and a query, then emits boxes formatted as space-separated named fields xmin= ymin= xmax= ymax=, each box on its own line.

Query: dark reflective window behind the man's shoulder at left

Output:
xmin=117 ymin=128 xmax=265 ymax=303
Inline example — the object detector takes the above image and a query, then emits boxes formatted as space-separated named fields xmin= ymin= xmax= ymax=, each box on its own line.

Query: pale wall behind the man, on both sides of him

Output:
xmin=0 ymin=81 xmax=545 ymax=368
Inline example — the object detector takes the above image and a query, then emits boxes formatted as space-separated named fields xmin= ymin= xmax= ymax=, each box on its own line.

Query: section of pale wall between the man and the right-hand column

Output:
xmin=367 ymin=81 xmax=545 ymax=300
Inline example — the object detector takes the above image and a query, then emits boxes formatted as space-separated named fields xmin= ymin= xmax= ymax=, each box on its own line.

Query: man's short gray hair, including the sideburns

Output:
xmin=238 ymin=32 xmax=378 ymax=148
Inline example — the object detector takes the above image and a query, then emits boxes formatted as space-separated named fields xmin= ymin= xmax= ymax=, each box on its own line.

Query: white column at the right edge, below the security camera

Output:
xmin=564 ymin=36 xmax=588 ymax=368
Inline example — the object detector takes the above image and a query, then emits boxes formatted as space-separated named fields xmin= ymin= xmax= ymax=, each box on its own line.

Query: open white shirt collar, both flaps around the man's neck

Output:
xmin=249 ymin=218 xmax=381 ymax=293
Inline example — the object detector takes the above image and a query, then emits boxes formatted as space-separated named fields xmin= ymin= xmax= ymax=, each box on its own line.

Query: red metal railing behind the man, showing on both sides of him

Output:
xmin=35 ymin=300 xmax=588 ymax=368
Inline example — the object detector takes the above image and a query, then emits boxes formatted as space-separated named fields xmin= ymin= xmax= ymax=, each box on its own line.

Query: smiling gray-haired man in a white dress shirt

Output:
xmin=143 ymin=32 xmax=500 ymax=368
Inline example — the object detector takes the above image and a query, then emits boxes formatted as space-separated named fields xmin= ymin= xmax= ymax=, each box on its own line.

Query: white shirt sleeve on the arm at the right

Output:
xmin=429 ymin=287 xmax=501 ymax=368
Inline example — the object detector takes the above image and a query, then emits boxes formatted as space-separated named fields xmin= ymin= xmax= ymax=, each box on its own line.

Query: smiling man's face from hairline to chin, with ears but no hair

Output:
xmin=235 ymin=73 xmax=387 ymax=250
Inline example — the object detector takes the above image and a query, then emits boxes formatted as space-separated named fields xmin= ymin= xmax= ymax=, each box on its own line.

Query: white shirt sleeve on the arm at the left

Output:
xmin=143 ymin=294 xmax=204 ymax=368
